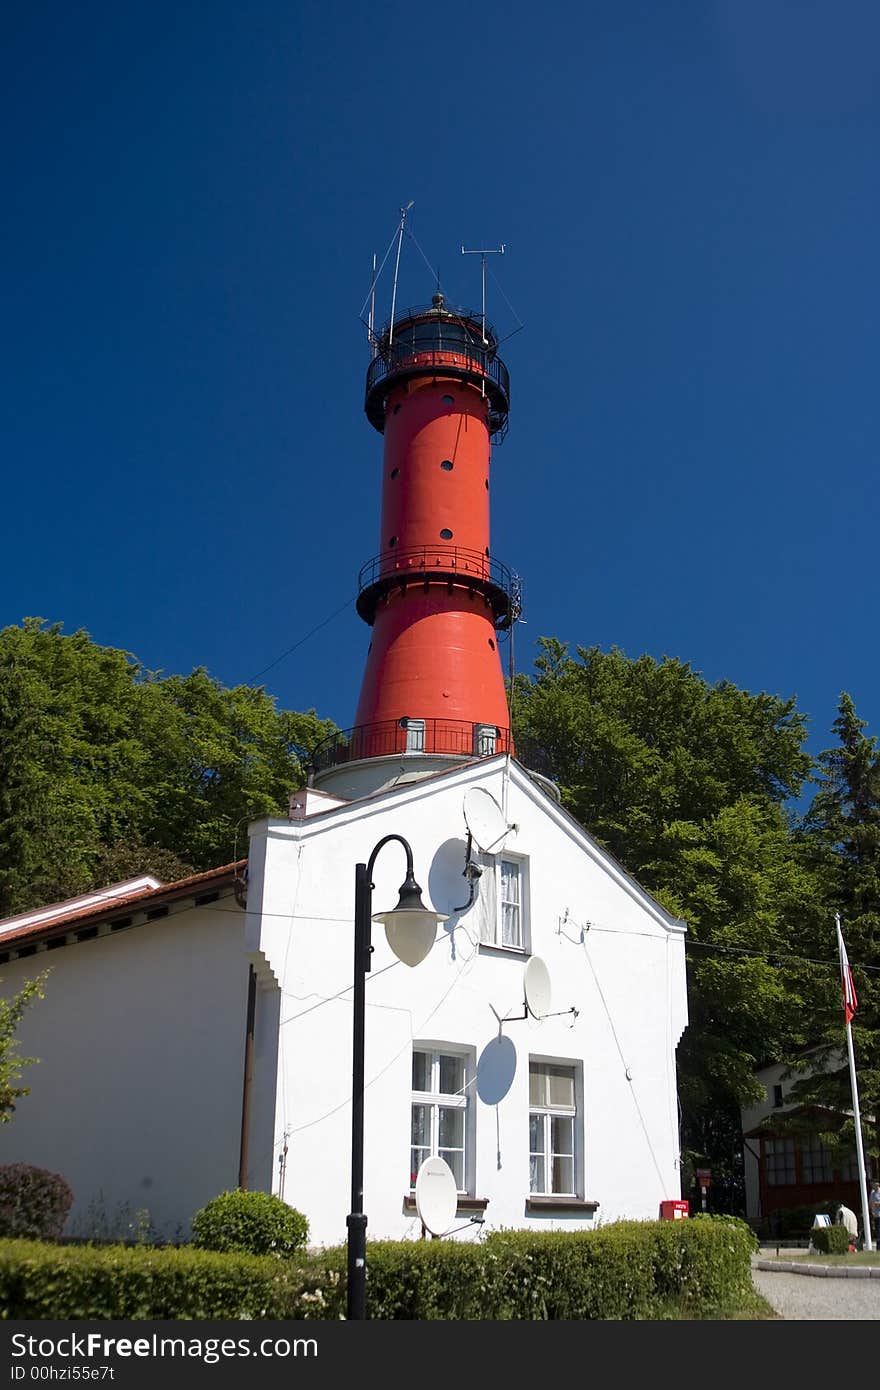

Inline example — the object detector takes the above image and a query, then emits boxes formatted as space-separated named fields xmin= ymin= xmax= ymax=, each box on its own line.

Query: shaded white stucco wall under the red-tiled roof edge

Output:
xmin=0 ymin=897 xmax=254 ymax=1238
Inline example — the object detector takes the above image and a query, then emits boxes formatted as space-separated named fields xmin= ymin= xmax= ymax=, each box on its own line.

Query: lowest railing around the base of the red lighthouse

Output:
xmin=306 ymin=717 xmax=513 ymax=776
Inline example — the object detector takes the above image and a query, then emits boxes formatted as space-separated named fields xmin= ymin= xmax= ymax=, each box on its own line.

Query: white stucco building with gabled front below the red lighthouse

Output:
xmin=0 ymin=755 xmax=687 ymax=1244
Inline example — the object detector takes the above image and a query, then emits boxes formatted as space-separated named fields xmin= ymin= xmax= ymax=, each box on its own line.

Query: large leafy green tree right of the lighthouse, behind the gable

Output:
xmin=513 ymin=638 xmax=822 ymax=1206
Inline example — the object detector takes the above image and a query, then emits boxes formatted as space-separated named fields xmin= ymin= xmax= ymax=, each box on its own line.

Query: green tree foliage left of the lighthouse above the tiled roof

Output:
xmin=0 ymin=619 xmax=335 ymax=916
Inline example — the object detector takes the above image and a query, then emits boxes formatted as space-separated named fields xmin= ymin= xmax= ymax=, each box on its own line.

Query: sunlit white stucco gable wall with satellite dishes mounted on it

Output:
xmin=247 ymin=759 xmax=687 ymax=1244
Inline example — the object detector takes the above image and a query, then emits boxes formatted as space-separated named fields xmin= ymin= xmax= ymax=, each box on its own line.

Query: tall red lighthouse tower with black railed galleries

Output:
xmin=311 ymin=291 xmax=519 ymax=796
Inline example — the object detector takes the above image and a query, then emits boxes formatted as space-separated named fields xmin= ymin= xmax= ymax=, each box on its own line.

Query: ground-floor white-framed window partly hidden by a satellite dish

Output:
xmin=410 ymin=1048 xmax=468 ymax=1193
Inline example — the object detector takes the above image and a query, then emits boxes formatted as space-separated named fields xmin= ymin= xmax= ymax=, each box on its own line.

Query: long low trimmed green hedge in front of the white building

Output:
xmin=0 ymin=1216 xmax=756 ymax=1321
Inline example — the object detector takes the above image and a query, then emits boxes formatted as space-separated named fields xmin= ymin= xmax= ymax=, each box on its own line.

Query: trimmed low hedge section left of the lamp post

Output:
xmin=0 ymin=1240 xmax=339 ymax=1321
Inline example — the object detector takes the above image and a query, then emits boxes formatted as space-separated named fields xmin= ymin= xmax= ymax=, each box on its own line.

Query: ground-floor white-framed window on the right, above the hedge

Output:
xmin=528 ymin=1062 xmax=577 ymax=1197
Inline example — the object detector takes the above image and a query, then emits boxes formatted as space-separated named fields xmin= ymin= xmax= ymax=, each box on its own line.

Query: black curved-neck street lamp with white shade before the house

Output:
xmin=346 ymin=835 xmax=446 ymax=1318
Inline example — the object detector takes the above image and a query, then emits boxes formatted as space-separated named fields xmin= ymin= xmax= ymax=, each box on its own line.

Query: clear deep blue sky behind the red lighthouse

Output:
xmin=0 ymin=0 xmax=880 ymax=778
